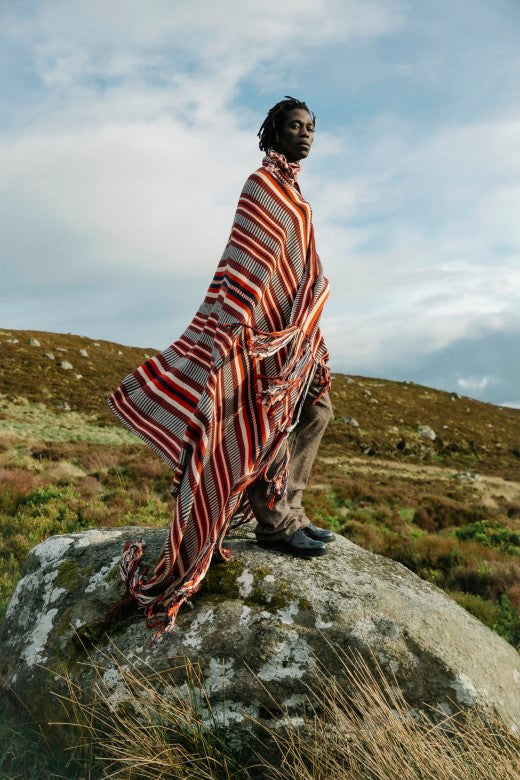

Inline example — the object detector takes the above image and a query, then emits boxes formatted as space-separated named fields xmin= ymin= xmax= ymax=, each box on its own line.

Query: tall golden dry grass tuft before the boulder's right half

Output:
xmin=258 ymin=653 xmax=520 ymax=780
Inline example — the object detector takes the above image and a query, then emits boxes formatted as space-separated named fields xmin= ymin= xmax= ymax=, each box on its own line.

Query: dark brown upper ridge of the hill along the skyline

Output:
xmin=0 ymin=329 xmax=520 ymax=480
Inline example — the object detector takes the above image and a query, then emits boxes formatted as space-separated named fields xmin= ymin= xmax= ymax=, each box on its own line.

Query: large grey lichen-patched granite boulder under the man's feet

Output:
xmin=0 ymin=528 xmax=520 ymax=756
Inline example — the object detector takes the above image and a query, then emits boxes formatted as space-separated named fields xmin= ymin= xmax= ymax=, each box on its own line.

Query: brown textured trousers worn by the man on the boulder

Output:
xmin=247 ymin=368 xmax=332 ymax=541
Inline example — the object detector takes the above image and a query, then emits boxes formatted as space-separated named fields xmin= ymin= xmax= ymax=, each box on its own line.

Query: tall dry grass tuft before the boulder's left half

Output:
xmin=52 ymin=644 xmax=250 ymax=780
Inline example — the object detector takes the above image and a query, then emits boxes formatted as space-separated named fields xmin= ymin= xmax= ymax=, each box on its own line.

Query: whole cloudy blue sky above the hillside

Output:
xmin=0 ymin=0 xmax=520 ymax=408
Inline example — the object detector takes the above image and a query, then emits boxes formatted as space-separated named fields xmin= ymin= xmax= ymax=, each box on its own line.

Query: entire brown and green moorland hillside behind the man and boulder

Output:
xmin=0 ymin=330 xmax=520 ymax=645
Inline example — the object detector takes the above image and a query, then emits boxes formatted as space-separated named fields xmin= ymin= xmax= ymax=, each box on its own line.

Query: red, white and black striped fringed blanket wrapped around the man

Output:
xmin=108 ymin=152 xmax=329 ymax=637
